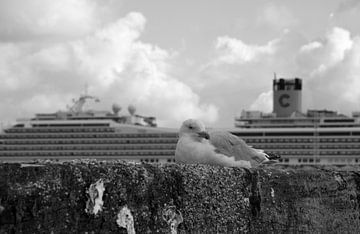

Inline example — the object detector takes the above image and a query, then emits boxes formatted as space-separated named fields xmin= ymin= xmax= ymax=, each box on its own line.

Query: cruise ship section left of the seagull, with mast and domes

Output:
xmin=0 ymin=94 xmax=178 ymax=162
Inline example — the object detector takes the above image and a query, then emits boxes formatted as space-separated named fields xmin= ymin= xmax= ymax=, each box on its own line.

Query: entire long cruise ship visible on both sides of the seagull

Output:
xmin=0 ymin=77 xmax=360 ymax=165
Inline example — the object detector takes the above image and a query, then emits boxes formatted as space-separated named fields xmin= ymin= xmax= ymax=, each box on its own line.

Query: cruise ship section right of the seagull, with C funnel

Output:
xmin=228 ymin=77 xmax=360 ymax=165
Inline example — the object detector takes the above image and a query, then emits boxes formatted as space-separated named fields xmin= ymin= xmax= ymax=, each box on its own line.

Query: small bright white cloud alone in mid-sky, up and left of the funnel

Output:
xmin=215 ymin=36 xmax=278 ymax=64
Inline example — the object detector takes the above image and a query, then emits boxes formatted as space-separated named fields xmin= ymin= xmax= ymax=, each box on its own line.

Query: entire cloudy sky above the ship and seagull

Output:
xmin=0 ymin=0 xmax=360 ymax=127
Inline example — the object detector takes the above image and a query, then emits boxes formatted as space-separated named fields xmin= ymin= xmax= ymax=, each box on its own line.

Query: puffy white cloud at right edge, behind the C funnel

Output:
xmin=297 ymin=27 xmax=360 ymax=114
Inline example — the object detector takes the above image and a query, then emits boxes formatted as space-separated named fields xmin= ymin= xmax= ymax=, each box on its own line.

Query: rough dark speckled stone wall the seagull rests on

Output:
xmin=0 ymin=161 xmax=360 ymax=233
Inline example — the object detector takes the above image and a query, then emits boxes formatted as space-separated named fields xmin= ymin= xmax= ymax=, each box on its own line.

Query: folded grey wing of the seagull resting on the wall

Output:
xmin=210 ymin=131 xmax=267 ymax=165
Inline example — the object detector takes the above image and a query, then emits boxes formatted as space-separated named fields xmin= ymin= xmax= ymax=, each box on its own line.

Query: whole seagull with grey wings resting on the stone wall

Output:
xmin=175 ymin=119 xmax=278 ymax=168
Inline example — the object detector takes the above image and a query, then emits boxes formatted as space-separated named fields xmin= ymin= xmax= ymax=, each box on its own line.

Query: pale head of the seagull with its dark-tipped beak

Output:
xmin=179 ymin=119 xmax=210 ymax=141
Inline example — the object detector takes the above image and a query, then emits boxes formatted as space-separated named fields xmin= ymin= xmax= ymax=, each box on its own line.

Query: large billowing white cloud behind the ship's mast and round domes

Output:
xmin=0 ymin=12 xmax=218 ymax=126
